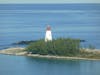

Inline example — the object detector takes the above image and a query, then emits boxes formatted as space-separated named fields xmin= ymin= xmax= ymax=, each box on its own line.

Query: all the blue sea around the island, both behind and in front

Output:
xmin=0 ymin=4 xmax=100 ymax=75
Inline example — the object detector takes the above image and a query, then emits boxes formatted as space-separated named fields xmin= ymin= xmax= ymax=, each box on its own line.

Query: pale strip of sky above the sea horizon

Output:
xmin=0 ymin=0 xmax=100 ymax=4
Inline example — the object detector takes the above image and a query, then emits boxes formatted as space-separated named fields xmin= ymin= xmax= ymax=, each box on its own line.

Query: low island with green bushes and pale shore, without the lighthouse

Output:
xmin=0 ymin=38 xmax=100 ymax=60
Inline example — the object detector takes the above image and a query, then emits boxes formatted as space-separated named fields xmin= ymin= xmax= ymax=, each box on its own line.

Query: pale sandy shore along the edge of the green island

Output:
xmin=0 ymin=47 xmax=100 ymax=60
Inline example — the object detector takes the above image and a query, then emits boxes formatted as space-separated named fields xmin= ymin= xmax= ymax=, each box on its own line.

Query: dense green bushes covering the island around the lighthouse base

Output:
xmin=26 ymin=38 xmax=80 ymax=56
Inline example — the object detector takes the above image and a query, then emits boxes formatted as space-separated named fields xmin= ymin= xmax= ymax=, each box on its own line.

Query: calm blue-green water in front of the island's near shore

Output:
xmin=0 ymin=55 xmax=100 ymax=75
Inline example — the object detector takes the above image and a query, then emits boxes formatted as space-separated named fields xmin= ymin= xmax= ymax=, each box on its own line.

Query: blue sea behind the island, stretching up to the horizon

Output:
xmin=0 ymin=4 xmax=100 ymax=49
